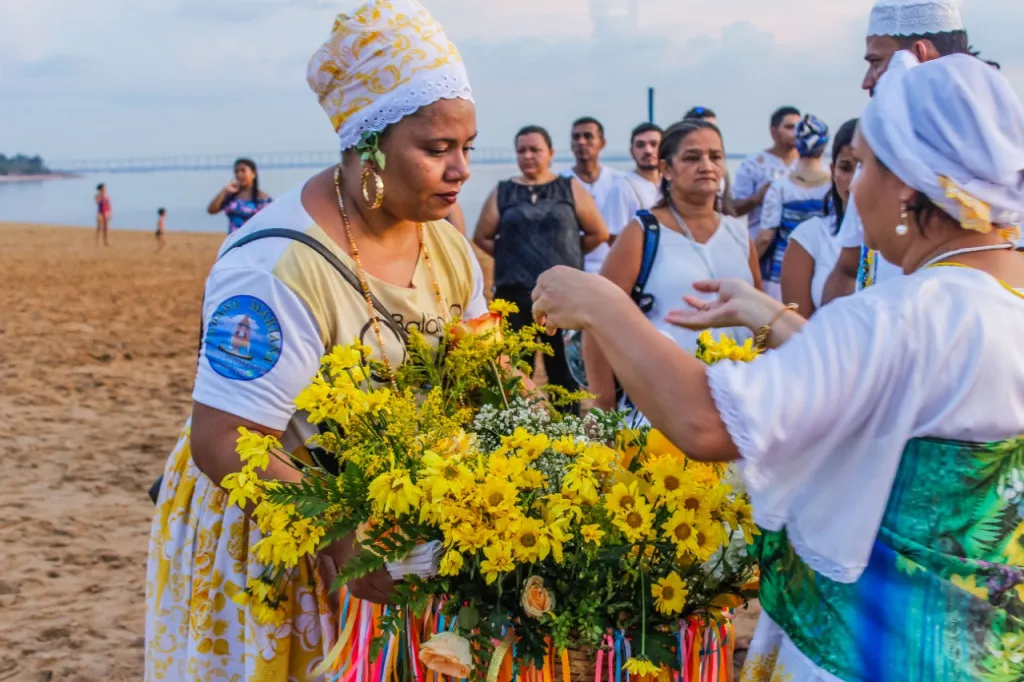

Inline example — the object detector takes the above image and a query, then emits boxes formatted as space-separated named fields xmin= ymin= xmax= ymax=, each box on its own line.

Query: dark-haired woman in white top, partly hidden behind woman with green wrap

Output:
xmin=782 ymin=119 xmax=857 ymax=317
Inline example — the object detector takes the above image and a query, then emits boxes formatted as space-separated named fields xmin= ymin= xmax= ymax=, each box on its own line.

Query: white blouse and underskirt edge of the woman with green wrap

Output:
xmin=708 ymin=267 xmax=1024 ymax=682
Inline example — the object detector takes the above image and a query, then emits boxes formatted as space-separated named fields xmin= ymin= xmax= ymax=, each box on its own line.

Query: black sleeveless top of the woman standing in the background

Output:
xmin=495 ymin=177 xmax=583 ymax=288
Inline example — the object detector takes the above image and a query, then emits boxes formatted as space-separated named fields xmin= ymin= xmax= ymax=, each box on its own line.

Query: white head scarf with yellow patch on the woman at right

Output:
xmin=860 ymin=52 xmax=1024 ymax=232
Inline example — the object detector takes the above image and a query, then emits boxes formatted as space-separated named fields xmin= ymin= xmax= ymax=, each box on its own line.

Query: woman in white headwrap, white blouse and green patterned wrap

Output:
xmin=534 ymin=53 xmax=1024 ymax=682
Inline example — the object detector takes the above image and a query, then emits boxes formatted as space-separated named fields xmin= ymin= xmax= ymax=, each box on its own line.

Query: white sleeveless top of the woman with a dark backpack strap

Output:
xmin=644 ymin=216 xmax=754 ymax=353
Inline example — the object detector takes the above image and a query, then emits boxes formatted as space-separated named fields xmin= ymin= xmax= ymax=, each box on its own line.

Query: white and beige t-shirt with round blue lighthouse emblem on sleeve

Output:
xmin=193 ymin=187 xmax=487 ymax=450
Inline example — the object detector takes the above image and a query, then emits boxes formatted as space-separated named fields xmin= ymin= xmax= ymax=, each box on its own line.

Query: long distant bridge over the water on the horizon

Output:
xmin=47 ymin=147 xmax=742 ymax=173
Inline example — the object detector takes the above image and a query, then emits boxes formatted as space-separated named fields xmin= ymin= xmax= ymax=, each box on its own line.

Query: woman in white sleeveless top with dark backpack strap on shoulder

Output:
xmin=584 ymin=120 xmax=761 ymax=410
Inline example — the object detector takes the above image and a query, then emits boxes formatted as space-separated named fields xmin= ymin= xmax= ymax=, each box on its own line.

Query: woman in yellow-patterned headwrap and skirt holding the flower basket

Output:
xmin=145 ymin=0 xmax=486 ymax=682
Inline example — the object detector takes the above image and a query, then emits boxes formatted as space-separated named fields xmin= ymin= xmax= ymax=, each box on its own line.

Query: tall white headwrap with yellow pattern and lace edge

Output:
xmin=306 ymin=0 xmax=473 ymax=152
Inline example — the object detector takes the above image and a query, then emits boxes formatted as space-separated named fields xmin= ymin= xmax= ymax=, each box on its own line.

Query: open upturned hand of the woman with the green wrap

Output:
xmin=665 ymin=280 xmax=783 ymax=331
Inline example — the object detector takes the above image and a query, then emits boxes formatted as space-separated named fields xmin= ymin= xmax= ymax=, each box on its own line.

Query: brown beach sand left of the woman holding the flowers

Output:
xmin=0 ymin=223 xmax=755 ymax=682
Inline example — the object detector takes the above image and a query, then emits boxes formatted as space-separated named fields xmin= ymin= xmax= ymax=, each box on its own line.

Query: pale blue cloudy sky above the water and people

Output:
xmin=0 ymin=0 xmax=1024 ymax=159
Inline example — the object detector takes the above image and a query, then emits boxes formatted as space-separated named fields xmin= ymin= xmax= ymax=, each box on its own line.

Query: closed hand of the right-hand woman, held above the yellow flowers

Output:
xmin=534 ymin=265 xmax=625 ymax=334
